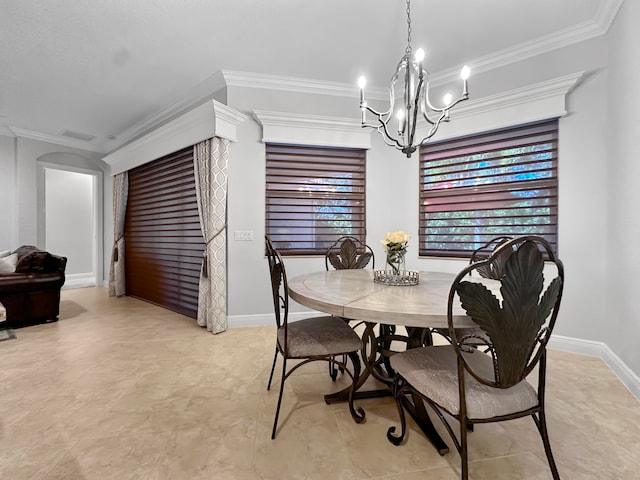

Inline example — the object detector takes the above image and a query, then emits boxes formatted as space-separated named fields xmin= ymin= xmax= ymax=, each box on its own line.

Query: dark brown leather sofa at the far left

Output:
xmin=0 ymin=245 xmax=67 ymax=328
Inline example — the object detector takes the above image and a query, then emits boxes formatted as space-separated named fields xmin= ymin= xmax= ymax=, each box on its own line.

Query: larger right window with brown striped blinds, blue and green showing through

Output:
xmin=419 ymin=119 xmax=558 ymax=257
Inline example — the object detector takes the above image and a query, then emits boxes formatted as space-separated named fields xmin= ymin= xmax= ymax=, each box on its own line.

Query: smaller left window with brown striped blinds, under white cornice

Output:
xmin=265 ymin=143 xmax=366 ymax=255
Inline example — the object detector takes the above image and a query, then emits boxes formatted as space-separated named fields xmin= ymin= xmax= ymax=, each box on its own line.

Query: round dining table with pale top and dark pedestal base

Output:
xmin=288 ymin=269 xmax=499 ymax=455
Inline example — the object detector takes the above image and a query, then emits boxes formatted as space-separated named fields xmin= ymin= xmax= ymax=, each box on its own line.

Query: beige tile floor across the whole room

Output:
xmin=0 ymin=288 xmax=640 ymax=480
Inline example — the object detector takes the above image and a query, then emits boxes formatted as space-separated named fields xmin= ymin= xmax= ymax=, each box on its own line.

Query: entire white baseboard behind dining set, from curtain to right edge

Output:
xmin=228 ymin=312 xmax=640 ymax=401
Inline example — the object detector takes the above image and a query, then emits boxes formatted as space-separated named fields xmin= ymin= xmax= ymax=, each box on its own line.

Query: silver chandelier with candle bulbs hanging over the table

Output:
xmin=358 ymin=0 xmax=469 ymax=158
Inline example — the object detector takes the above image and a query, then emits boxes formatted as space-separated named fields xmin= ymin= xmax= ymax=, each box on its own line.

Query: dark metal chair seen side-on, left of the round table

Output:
xmin=265 ymin=237 xmax=365 ymax=439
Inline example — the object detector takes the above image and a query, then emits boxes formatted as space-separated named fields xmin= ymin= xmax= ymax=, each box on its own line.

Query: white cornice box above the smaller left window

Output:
xmin=253 ymin=110 xmax=371 ymax=149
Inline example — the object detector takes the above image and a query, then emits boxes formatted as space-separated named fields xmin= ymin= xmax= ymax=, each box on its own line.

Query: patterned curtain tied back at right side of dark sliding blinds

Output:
xmin=193 ymin=137 xmax=229 ymax=333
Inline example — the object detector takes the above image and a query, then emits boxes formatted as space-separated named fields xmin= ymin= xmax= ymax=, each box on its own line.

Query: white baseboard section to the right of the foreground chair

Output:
xmin=549 ymin=335 xmax=640 ymax=401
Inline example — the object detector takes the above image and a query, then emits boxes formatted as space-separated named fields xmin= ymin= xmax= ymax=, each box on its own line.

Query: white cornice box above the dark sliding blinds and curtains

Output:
xmin=103 ymin=100 xmax=248 ymax=175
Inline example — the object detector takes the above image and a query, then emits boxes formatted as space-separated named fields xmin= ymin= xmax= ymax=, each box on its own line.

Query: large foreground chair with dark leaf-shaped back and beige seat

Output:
xmin=387 ymin=236 xmax=564 ymax=480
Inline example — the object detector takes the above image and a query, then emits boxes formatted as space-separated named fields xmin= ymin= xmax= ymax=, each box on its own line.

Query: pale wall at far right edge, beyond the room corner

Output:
xmin=594 ymin=1 xmax=640 ymax=376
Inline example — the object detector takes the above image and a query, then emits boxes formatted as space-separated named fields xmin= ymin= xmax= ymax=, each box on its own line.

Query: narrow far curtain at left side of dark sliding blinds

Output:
xmin=109 ymin=172 xmax=129 ymax=297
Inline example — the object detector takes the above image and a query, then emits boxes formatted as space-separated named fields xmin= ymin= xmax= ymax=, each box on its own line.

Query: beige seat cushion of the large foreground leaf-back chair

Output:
xmin=391 ymin=345 xmax=538 ymax=420
